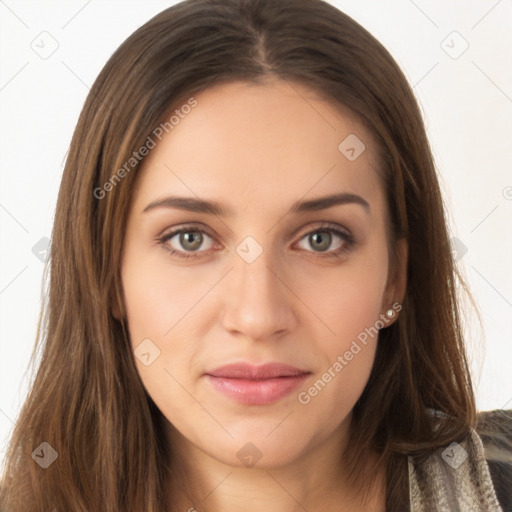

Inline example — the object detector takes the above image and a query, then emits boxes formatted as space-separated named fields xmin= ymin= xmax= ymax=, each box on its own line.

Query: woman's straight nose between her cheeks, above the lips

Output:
xmin=222 ymin=245 xmax=299 ymax=341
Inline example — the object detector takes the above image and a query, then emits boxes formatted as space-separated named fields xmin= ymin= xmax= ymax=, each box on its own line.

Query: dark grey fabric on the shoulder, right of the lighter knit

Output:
xmin=476 ymin=409 xmax=512 ymax=511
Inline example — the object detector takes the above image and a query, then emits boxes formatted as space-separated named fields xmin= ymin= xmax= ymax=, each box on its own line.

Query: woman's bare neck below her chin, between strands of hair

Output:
xmin=166 ymin=416 xmax=385 ymax=512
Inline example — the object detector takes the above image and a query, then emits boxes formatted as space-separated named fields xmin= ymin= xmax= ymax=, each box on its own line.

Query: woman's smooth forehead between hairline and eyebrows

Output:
xmin=134 ymin=81 xmax=381 ymax=215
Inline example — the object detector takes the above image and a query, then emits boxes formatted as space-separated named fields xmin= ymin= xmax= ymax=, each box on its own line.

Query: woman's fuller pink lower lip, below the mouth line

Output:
xmin=203 ymin=373 xmax=309 ymax=405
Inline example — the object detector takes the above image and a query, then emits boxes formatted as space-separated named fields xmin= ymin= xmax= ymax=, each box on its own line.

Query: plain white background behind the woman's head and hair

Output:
xmin=0 ymin=0 xmax=512 ymax=466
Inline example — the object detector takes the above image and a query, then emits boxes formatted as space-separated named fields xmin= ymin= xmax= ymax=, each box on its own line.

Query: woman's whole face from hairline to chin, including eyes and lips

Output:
xmin=118 ymin=81 xmax=401 ymax=467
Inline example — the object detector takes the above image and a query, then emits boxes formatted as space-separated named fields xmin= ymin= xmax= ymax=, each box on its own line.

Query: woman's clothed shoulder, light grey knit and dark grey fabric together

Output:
xmin=409 ymin=411 xmax=512 ymax=512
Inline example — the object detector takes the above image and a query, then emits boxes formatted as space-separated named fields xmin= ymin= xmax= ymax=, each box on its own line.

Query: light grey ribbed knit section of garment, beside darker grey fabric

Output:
xmin=408 ymin=429 xmax=503 ymax=512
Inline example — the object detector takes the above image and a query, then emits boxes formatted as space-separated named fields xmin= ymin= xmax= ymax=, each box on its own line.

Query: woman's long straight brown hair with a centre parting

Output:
xmin=0 ymin=0 xmax=476 ymax=512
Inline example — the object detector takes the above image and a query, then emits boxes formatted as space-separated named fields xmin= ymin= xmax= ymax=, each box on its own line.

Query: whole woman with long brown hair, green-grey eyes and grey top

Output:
xmin=0 ymin=0 xmax=510 ymax=512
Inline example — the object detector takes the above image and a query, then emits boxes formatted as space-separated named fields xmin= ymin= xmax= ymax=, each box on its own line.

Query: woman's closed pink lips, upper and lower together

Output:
xmin=206 ymin=363 xmax=310 ymax=405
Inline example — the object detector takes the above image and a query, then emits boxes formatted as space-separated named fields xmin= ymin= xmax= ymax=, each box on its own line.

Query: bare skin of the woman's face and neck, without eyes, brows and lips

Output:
xmin=121 ymin=81 xmax=406 ymax=512
